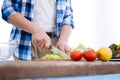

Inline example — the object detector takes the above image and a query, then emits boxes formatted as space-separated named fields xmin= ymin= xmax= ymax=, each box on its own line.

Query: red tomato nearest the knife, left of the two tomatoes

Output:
xmin=70 ymin=50 xmax=83 ymax=61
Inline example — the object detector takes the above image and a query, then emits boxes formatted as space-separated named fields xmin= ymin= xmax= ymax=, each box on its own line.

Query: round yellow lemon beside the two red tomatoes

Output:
xmin=97 ymin=47 xmax=112 ymax=61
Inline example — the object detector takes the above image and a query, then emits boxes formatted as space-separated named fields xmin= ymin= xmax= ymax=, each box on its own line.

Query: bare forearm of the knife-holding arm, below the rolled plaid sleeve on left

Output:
xmin=8 ymin=13 xmax=38 ymax=34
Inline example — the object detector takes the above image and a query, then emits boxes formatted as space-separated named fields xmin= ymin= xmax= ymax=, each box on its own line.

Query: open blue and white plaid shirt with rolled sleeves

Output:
xmin=1 ymin=0 xmax=74 ymax=60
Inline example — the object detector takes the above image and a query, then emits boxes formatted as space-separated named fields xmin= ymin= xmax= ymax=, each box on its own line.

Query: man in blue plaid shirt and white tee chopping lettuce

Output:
xmin=2 ymin=0 xmax=74 ymax=60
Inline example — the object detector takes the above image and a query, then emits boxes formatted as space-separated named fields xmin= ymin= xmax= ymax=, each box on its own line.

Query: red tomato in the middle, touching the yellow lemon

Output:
xmin=83 ymin=48 xmax=97 ymax=61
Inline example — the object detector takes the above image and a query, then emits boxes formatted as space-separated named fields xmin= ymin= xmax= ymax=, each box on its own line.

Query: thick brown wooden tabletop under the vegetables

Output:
xmin=0 ymin=61 xmax=120 ymax=79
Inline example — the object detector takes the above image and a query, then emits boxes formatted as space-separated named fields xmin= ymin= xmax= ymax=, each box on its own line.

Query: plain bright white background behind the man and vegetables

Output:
xmin=0 ymin=0 xmax=120 ymax=49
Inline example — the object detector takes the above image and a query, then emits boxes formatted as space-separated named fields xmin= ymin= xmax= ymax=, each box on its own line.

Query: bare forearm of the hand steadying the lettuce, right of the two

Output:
xmin=59 ymin=25 xmax=72 ymax=42
